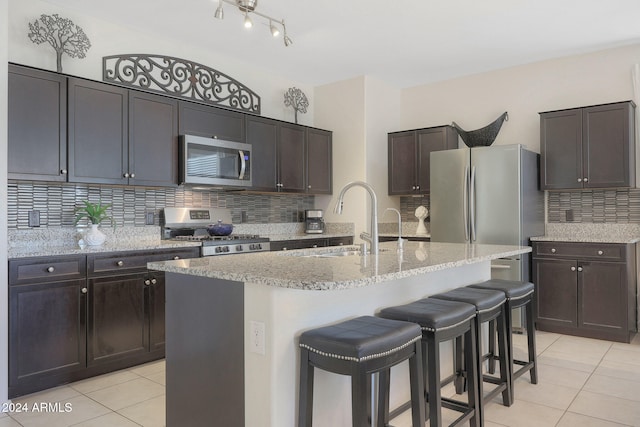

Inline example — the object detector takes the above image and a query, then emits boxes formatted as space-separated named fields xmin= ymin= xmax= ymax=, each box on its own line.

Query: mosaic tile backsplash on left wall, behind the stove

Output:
xmin=7 ymin=181 xmax=314 ymax=229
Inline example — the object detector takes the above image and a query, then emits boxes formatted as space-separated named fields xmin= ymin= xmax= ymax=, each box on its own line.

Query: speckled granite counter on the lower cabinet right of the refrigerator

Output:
xmin=531 ymin=223 xmax=640 ymax=244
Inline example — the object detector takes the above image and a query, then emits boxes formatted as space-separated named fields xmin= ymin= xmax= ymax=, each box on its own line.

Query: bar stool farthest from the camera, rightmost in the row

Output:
xmin=469 ymin=279 xmax=538 ymax=401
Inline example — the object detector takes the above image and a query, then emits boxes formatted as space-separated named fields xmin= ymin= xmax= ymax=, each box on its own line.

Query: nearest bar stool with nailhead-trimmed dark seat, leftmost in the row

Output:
xmin=298 ymin=316 xmax=425 ymax=427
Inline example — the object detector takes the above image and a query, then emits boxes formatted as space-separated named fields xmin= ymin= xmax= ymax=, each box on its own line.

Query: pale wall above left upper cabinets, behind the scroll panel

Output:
xmin=4 ymin=0 xmax=313 ymax=125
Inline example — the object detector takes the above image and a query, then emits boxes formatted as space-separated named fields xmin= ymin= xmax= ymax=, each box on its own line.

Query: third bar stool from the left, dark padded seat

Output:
xmin=430 ymin=287 xmax=512 ymax=422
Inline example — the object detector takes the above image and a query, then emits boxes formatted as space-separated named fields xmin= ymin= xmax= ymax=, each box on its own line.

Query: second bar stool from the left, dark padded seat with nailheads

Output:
xmin=377 ymin=298 xmax=482 ymax=427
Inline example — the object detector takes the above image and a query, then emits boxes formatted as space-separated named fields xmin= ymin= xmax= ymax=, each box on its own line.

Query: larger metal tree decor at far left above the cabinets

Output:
xmin=29 ymin=13 xmax=91 ymax=73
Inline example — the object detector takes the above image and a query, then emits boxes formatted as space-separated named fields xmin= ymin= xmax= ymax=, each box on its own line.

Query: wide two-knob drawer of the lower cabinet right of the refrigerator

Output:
xmin=533 ymin=242 xmax=627 ymax=261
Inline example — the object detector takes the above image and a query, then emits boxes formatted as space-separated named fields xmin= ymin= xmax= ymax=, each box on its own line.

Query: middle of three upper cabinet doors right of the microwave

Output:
xmin=278 ymin=124 xmax=306 ymax=193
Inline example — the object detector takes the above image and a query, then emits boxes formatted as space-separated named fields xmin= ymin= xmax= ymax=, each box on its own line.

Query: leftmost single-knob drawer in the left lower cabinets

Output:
xmin=9 ymin=256 xmax=87 ymax=285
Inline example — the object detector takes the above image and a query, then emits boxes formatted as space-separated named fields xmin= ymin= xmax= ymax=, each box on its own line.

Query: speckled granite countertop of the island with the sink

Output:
xmin=148 ymin=242 xmax=531 ymax=290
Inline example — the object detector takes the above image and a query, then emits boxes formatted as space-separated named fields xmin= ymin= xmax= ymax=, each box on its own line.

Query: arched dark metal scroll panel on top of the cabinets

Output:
xmin=102 ymin=54 xmax=260 ymax=114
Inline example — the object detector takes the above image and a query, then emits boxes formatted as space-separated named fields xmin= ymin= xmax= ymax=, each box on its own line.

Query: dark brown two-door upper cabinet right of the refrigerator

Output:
xmin=540 ymin=101 xmax=636 ymax=190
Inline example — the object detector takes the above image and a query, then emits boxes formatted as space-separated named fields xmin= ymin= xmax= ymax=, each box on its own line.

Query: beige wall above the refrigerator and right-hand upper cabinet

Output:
xmin=402 ymin=45 xmax=640 ymax=152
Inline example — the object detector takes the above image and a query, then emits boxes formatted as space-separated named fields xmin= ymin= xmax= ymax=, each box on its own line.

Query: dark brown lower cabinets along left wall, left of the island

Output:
xmin=9 ymin=248 xmax=199 ymax=398
